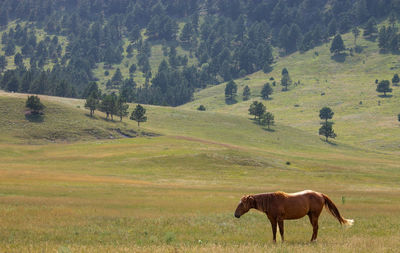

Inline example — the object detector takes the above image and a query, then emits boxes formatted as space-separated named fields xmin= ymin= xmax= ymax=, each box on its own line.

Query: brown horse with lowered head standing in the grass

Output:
xmin=235 ymin=190 xmax=354 ymax=242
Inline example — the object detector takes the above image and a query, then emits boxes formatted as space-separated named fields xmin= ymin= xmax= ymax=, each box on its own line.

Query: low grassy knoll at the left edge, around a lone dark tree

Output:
xmin=0 ymin=91 xmax=145 ymax=144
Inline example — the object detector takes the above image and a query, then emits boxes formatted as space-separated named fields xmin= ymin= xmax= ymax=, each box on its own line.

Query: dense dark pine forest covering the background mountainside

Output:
xmin=0 ymin=0 xmax=400 ymax=106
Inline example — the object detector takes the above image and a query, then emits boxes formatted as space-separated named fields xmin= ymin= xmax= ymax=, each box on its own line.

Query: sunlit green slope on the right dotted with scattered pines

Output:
xmin=181 ymin=27 xmax=400 ymax=152
